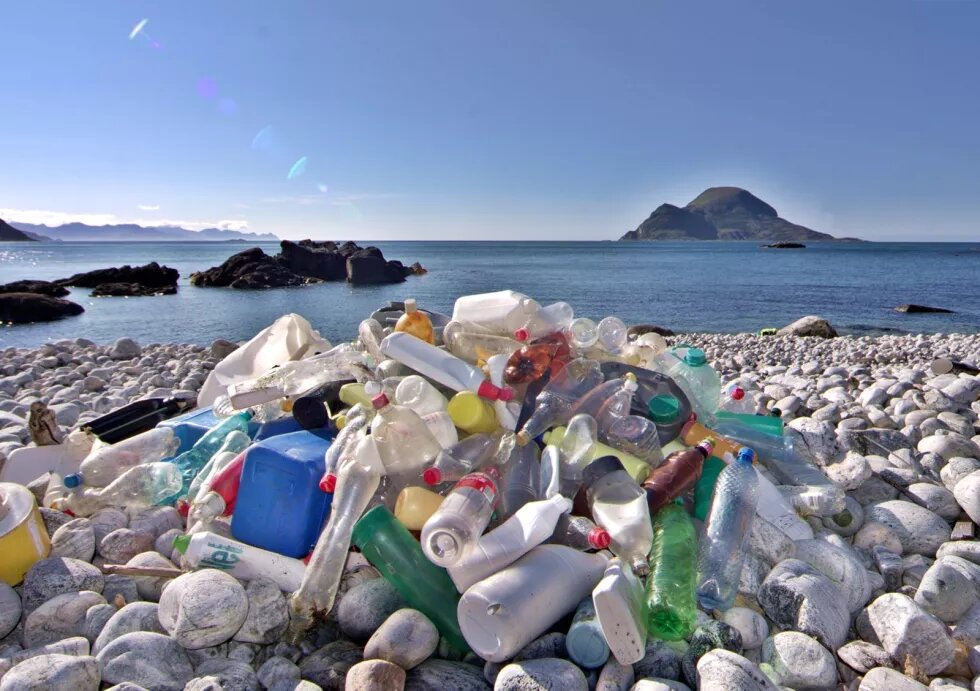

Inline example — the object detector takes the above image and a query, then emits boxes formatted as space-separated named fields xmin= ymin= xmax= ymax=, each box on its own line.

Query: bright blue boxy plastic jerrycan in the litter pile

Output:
xmin=231 ymin=430 xmax=333 ymax=558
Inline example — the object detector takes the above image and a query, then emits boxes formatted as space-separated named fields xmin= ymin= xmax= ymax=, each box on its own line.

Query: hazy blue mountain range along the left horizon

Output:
xmin=10 ymin=223 xmax=279 ymax=242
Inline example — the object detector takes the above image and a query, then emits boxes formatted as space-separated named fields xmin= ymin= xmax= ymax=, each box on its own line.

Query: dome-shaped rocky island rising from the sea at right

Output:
xmin=620 ymin=187 xmax=864 ymax=242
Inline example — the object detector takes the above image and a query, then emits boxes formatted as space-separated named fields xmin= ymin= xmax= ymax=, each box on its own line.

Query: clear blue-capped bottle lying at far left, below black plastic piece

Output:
xmin=64 ymin=427 xmax=180 ymax=489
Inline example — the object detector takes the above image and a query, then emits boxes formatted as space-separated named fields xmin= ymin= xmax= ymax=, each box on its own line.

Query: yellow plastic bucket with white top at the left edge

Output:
xmin=0 ymin=482 xmax=51 ymax=585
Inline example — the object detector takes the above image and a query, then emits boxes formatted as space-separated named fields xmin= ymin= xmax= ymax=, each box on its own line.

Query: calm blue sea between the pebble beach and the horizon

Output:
xmin=0 ymin=242 xmax=980 ymax=346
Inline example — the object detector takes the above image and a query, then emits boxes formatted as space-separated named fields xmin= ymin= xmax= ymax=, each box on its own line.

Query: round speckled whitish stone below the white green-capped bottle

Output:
xmin=158 ymin=569 xmax=247 ymax=649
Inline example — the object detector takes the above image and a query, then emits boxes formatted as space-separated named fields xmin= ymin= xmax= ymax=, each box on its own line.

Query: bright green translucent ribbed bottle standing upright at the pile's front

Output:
xmin=647 ymin=504 xmax=698 ymax=641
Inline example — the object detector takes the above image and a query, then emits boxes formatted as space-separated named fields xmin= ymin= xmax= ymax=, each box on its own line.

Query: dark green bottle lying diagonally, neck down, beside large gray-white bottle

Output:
xmin=351 ymin=505 xmax=469 ymax=654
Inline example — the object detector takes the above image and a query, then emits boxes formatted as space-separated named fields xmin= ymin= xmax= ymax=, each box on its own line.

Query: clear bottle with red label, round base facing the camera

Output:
xmin=421 ymin=469 xmax=499 ymax=567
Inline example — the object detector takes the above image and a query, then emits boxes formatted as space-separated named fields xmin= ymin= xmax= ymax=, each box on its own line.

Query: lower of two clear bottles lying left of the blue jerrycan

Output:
xmin=52 ymin=462 xmax=183 ymax=516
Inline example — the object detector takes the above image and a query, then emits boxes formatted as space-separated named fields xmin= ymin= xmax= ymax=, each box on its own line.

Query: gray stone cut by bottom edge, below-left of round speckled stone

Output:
xmin=96 ymin=631 xmax=194 ymax=691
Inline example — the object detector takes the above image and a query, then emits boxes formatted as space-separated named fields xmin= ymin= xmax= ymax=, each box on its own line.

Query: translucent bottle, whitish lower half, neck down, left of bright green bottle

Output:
xmin=582 ymin=456 xmax=653 ymax=576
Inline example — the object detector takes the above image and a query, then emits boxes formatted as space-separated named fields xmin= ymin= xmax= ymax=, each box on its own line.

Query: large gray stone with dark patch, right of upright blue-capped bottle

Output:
xmin=758 ymin=559 xmax=850 ymax=650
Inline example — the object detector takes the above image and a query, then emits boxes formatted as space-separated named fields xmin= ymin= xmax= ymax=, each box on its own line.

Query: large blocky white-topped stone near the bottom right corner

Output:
xmin=868 ymin=593 xmax=953 ymax=675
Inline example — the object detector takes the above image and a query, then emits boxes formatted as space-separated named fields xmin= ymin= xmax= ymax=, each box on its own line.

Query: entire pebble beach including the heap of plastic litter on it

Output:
xmin=0 ymin=291 xmax=980 ymax=691
